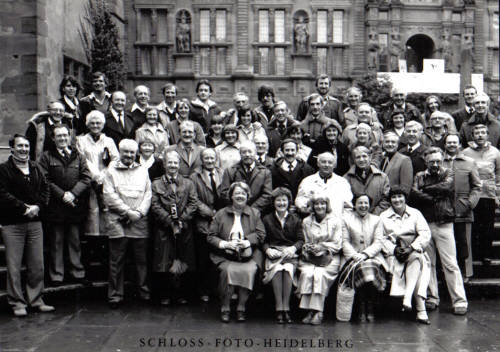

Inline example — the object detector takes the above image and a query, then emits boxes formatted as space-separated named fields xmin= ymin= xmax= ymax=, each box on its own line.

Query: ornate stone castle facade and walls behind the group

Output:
xmin=0 ymin=0 xmax=499 ymax=145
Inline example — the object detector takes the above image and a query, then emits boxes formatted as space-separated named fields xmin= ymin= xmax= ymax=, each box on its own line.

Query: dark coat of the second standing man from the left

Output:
xmin=40 ymin=150 xmax=92 ymax=223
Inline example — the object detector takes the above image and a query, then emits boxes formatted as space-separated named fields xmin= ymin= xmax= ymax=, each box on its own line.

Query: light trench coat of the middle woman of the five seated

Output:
xmin=297 ymin=213 xmax=342 ymax=296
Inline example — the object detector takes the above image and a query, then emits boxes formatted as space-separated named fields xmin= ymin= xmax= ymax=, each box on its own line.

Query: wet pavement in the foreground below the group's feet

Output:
xmin=0 ymin=292 xmax=500 ymax=352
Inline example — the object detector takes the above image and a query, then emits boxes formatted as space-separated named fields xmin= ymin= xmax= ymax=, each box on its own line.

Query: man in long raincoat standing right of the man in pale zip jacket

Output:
xmin=150 ymin=151 xmax=198 ymax=306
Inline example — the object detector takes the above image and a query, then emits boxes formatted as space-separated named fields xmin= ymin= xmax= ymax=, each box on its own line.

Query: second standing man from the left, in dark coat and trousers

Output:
xmin=40 ymin=125 xmax=91 ymax=286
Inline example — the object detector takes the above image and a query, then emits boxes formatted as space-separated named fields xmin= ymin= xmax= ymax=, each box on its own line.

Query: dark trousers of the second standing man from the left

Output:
xmin=48 ymin=223 xmax=85 ymax=281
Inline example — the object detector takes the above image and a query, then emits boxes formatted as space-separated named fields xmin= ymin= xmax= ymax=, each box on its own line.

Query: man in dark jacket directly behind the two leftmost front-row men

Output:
xmin=26 ymin=101 xmax=74 ymax=160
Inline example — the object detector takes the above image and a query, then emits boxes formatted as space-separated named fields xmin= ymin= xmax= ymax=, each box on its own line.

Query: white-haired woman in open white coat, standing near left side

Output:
xmin=76 ymin=110 xmax=119 ymax=236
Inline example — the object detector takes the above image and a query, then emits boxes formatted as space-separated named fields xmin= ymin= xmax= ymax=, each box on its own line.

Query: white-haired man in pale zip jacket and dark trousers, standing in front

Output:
xmin=103 ymin=139 xmax=151 ymax=309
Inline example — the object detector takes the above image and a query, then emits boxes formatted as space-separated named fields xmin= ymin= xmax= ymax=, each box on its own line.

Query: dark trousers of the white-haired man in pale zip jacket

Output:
xmin=108 ymin=237 xmax=150 ymax=302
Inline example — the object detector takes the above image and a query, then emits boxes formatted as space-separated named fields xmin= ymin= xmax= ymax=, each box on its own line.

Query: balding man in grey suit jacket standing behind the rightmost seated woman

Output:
xmin=380 ymin=132 xmax=413 ymax=194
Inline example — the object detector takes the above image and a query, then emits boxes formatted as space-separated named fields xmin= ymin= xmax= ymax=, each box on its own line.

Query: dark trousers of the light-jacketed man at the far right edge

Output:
xmin=472 ymin=198 xmax=495 ymax=260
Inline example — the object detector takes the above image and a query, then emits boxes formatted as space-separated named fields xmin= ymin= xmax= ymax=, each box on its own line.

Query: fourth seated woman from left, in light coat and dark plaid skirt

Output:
xmin=340 ymin=194 xmax=389 ymax=322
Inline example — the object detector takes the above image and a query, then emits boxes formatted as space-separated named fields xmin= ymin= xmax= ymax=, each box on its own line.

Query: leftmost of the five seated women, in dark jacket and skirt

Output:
xmin=207 ymin=182 xmax=266 ymax=323
